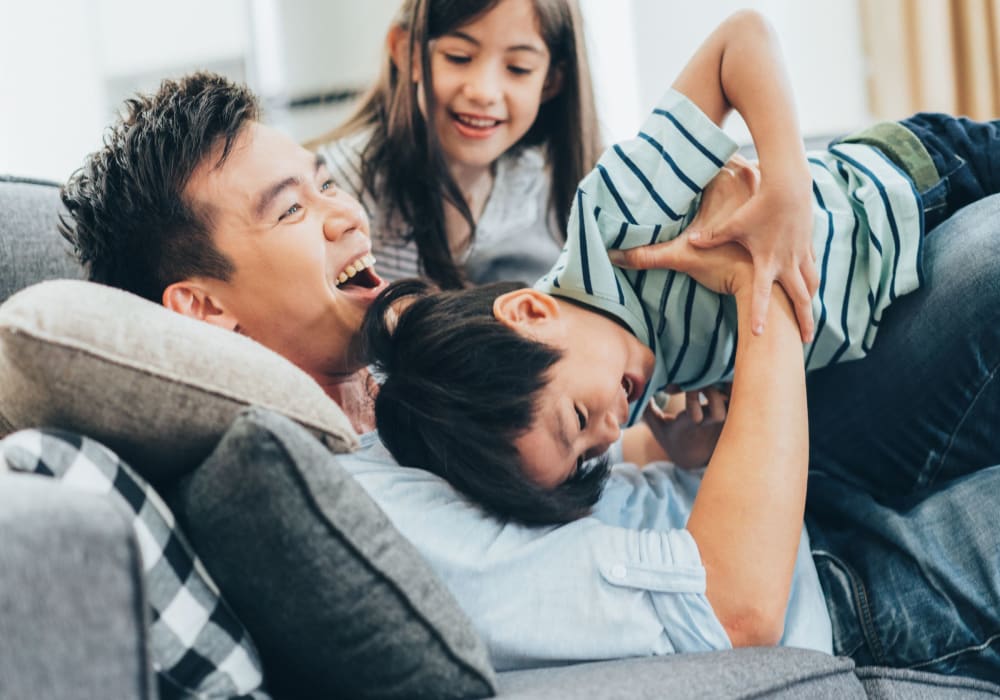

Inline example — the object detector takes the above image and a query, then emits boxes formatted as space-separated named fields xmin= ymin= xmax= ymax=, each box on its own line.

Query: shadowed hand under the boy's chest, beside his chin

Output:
xmin=643 ymin=388 xmax=728 ymax=469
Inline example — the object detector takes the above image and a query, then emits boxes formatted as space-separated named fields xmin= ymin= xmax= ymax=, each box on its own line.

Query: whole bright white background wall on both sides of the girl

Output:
xmin=0 ymin=0 xmax=867 ymax=180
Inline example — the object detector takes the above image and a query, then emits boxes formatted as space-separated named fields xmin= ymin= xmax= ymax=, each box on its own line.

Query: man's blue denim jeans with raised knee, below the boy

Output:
xmin=806 ymin=194 xmax=1000 ymax=681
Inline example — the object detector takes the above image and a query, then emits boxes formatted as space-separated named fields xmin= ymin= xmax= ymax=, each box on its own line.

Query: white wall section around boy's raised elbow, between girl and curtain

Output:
xmin=581 ymin=0 xmax=868 ymax=142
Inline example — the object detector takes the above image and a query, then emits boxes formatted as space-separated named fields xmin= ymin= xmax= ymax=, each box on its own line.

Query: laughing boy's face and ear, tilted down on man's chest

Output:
xmin=494 ymin=290 xmax=654 ymax=488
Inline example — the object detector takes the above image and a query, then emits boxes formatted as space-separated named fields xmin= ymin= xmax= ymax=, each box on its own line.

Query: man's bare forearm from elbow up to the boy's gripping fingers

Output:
xmin=688 ymin=287 xmax=808 ymax=646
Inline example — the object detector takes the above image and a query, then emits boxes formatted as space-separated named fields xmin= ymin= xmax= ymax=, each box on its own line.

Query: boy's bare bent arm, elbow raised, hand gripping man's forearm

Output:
xmin=673 ymin=10 xmax=819 ymax=341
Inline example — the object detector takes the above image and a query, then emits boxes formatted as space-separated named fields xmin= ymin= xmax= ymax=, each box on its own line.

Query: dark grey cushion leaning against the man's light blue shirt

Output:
xmin=168 ymin=409 xmax=495 ymax=699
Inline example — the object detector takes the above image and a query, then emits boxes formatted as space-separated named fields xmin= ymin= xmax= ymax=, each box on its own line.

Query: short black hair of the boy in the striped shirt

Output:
xmin=361 ymin=280 xmax=608 ymax=524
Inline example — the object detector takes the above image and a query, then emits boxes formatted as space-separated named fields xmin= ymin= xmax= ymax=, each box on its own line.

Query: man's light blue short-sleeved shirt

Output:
xmin=337 ymin=433 xmax=832 ymax=670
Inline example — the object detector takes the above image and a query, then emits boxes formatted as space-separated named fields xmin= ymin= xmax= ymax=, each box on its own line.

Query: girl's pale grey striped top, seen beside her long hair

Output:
xmin=318 ymin=133 xmax=562 ymax=284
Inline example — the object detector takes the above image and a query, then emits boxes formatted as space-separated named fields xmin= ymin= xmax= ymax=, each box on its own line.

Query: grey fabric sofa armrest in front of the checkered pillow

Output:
xmin=0 ymin=471 xmax=155 ymax=699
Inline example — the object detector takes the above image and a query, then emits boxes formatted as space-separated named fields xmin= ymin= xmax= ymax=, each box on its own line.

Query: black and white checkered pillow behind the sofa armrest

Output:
xmin=0 ymin=430 xmax=268 ymax=700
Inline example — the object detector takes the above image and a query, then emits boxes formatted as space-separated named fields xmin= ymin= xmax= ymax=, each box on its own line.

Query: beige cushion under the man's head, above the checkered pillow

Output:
xmin=0 ymin=280 xmax=357 ymax=484
